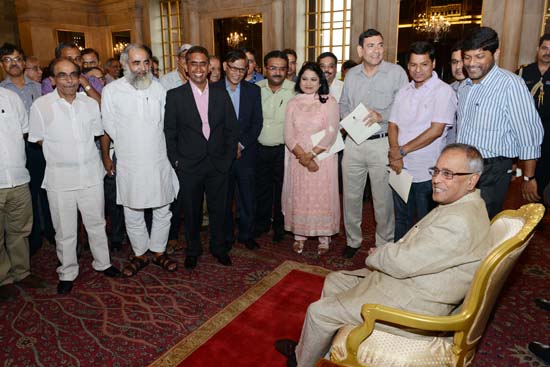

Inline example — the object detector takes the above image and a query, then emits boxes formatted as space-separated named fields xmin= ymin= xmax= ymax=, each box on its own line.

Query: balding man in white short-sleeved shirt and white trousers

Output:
xmin=29 ymin=58 xmax=120 ymax=294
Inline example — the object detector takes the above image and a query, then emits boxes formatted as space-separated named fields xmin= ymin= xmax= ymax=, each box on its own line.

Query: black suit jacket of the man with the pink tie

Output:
xmin=164 ymin=83 xmax=239 ymax=172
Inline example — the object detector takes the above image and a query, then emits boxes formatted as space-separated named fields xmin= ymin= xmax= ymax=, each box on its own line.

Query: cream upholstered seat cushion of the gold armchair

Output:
xmin=331 ymin=325 xmax=454 ymax=367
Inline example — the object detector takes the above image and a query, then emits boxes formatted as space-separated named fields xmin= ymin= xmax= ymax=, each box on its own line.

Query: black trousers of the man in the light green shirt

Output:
xmin=255 ymin=144 xmax=285 ymax=233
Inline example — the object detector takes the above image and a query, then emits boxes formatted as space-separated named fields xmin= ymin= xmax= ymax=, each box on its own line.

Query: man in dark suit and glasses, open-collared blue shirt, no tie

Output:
xmin=212 ymin=50 xmax=263 ymax=249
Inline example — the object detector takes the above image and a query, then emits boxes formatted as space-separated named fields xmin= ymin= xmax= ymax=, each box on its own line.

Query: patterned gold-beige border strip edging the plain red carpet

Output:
xmin=149 ymin=260 xmax=330 ymax=367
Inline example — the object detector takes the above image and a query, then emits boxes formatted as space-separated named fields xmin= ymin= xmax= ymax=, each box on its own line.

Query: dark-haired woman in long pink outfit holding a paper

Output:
xmin=281 ymin=62 xmax=340 ymax=255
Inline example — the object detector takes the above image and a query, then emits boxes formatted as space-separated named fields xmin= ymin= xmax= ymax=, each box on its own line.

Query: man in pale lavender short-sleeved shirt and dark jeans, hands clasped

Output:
xmin=388 ymin=41 xmax=457 ymax=241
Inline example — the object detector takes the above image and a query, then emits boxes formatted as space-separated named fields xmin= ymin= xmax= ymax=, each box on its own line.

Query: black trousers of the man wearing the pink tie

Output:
xmin=178 ymin=158 xmax=230 ymax=256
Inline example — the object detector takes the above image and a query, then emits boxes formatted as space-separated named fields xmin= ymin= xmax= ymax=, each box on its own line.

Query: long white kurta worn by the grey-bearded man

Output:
xmin=101 ymin=78 xmax=179 ymax=209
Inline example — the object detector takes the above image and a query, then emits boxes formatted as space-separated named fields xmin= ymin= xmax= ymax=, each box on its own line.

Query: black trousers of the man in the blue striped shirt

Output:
xmin=477 ymin=157 xmax=512 ymax=219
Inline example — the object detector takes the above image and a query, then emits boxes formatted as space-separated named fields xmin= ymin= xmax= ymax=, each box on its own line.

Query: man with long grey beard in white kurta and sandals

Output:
xmin=101 ymin=44 xmax=179 ymax=277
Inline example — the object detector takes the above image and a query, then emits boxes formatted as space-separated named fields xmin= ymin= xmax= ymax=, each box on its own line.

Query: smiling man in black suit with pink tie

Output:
xmin=164 ymin=46 xmax=239 ymax=269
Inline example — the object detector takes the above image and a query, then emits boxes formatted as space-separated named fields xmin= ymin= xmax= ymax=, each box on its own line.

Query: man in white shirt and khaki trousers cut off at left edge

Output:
xmin=0 ymin=88 xmax=45 ymax=302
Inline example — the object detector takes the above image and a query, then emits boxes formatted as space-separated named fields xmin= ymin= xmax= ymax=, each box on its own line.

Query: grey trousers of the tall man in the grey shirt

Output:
xmin=342 ymin=137 xmax=395 ymax=248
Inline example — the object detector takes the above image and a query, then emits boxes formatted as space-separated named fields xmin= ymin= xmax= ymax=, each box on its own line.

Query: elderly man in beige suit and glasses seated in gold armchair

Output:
xmin=275 ymin=144 xmax=491 ymax=367
